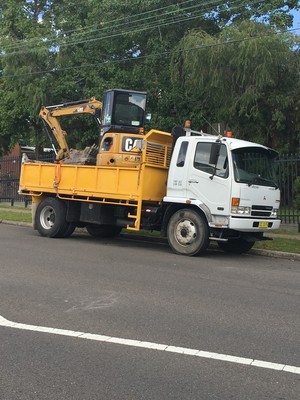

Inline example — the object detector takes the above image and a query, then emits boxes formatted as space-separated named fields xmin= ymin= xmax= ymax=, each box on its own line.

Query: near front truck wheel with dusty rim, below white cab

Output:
xmin=167 ymin=208 xmax=209 ymax=256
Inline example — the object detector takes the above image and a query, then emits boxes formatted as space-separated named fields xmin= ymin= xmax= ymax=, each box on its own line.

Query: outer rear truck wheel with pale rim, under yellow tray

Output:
xmin=35 ymin=197 xmax=68 ymax=238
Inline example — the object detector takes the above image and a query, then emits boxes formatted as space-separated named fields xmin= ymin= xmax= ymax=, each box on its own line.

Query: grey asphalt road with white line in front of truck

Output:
xmin=0 ymin=224 xmax=300 ymax=400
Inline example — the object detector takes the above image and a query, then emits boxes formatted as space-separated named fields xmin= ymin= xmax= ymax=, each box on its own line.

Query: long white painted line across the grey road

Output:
xmin=0 ymin=315 xmax=300 ymax=374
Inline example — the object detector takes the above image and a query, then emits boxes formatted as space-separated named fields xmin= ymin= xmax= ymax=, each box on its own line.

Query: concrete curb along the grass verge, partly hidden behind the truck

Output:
xmin=0 ymin=219 xmax=300 ymax=261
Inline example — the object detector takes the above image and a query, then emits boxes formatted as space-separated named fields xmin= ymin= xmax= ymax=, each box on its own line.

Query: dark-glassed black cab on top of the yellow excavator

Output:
xmin=102 ymin=89 xmax=146 ymax=133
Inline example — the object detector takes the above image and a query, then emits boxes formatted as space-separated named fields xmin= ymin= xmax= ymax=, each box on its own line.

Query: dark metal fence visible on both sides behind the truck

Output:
xmin=0 ymin=154 xmax=300 ymax=224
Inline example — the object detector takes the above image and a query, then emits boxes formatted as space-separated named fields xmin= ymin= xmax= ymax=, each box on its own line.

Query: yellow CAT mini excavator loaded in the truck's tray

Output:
xmin=40 ymin=89 xmax=146 ymax=167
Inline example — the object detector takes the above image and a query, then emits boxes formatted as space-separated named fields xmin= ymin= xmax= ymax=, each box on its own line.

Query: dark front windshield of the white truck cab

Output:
xmin=232 ymin=147 xmax=278 ymax=188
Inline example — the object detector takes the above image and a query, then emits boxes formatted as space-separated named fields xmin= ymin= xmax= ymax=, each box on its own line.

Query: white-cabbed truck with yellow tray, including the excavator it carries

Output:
xmin=19 ymin=89 xmax=280 ymax=256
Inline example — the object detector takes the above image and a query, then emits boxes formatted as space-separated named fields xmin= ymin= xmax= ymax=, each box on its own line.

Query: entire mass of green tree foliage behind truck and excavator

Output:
xmin=0 ymin=0 xmax=300 ymax=153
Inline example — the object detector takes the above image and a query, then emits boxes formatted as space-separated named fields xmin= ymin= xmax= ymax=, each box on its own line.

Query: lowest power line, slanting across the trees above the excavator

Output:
xmin=1 ymin=28 xmax=300 ymax=79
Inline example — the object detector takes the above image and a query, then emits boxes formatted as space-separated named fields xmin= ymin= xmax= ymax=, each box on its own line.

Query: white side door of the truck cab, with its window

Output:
xmin=187 ymin=141 xmax=231 ymax=215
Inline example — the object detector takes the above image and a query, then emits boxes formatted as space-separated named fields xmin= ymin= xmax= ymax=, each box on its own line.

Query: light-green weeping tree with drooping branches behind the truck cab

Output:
xmin=173 ymin=21 xmax=300 ymax=151
